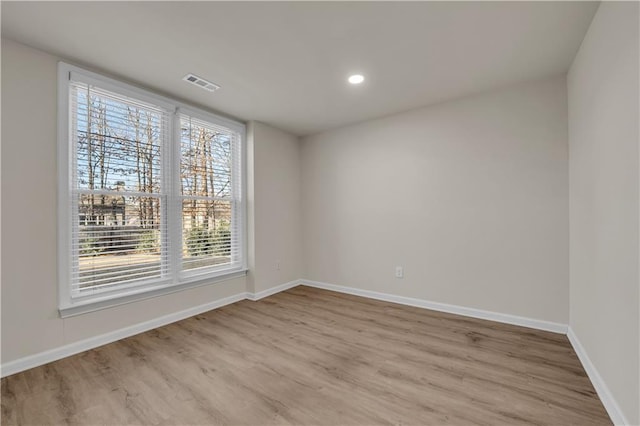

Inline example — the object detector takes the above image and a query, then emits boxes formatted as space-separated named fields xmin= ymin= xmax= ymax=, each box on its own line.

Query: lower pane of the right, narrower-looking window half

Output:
xmin=182 ymin=199 xmax=231 ymax=269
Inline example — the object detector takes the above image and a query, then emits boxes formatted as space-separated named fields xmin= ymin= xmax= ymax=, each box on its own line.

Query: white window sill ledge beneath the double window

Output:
xmin=58 ymin=269 xmax=247 ymax=318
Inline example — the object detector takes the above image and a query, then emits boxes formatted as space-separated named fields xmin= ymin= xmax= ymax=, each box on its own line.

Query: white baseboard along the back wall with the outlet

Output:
xmin=300 ymin=280 xmax=567 ymax=334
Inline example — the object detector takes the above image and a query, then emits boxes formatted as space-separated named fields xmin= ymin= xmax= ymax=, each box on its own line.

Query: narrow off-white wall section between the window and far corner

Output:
xmin=247 ymin=121 xmax=302 ymax=293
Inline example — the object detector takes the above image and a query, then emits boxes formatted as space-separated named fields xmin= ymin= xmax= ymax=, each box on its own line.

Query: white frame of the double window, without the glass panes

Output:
xmin=57 ymin=62 xmax=248 ymax=318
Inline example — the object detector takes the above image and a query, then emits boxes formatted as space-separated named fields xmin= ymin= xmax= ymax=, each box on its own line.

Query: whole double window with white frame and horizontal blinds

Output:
xmin=59 ymin=63 xmax=246 ymax=316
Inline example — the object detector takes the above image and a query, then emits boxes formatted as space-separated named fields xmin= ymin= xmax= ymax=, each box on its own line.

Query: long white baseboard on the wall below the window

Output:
xmin=0 ymin=293 xmax=248 ymax=377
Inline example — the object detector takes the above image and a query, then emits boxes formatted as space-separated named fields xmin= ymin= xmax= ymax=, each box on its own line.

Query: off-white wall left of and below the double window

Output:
xmin=1 ymin=40 xmax=246 ymax=364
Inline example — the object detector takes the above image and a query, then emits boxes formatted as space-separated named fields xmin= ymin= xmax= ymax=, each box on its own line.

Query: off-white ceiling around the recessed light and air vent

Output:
xmin=2 ymin=1 xmax=598 ymax=135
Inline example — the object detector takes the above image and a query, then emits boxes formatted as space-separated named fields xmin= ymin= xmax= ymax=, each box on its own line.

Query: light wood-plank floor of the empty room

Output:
xmin=1 ymin=286 xmax=611 ymax=425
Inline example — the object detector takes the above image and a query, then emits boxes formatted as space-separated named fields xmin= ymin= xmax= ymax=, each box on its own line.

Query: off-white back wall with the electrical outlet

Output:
xmin=302 ymin=76 xmax=569 ymax=324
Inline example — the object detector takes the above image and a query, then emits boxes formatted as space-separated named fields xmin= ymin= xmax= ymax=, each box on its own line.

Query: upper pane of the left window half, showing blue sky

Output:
xmin=74 ymin=86 xmax=163 ymax=192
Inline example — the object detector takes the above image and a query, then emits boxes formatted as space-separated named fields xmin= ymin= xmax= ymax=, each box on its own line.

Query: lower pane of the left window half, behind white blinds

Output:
xmin=74 ymin=194 xmax=165 ymax=290
